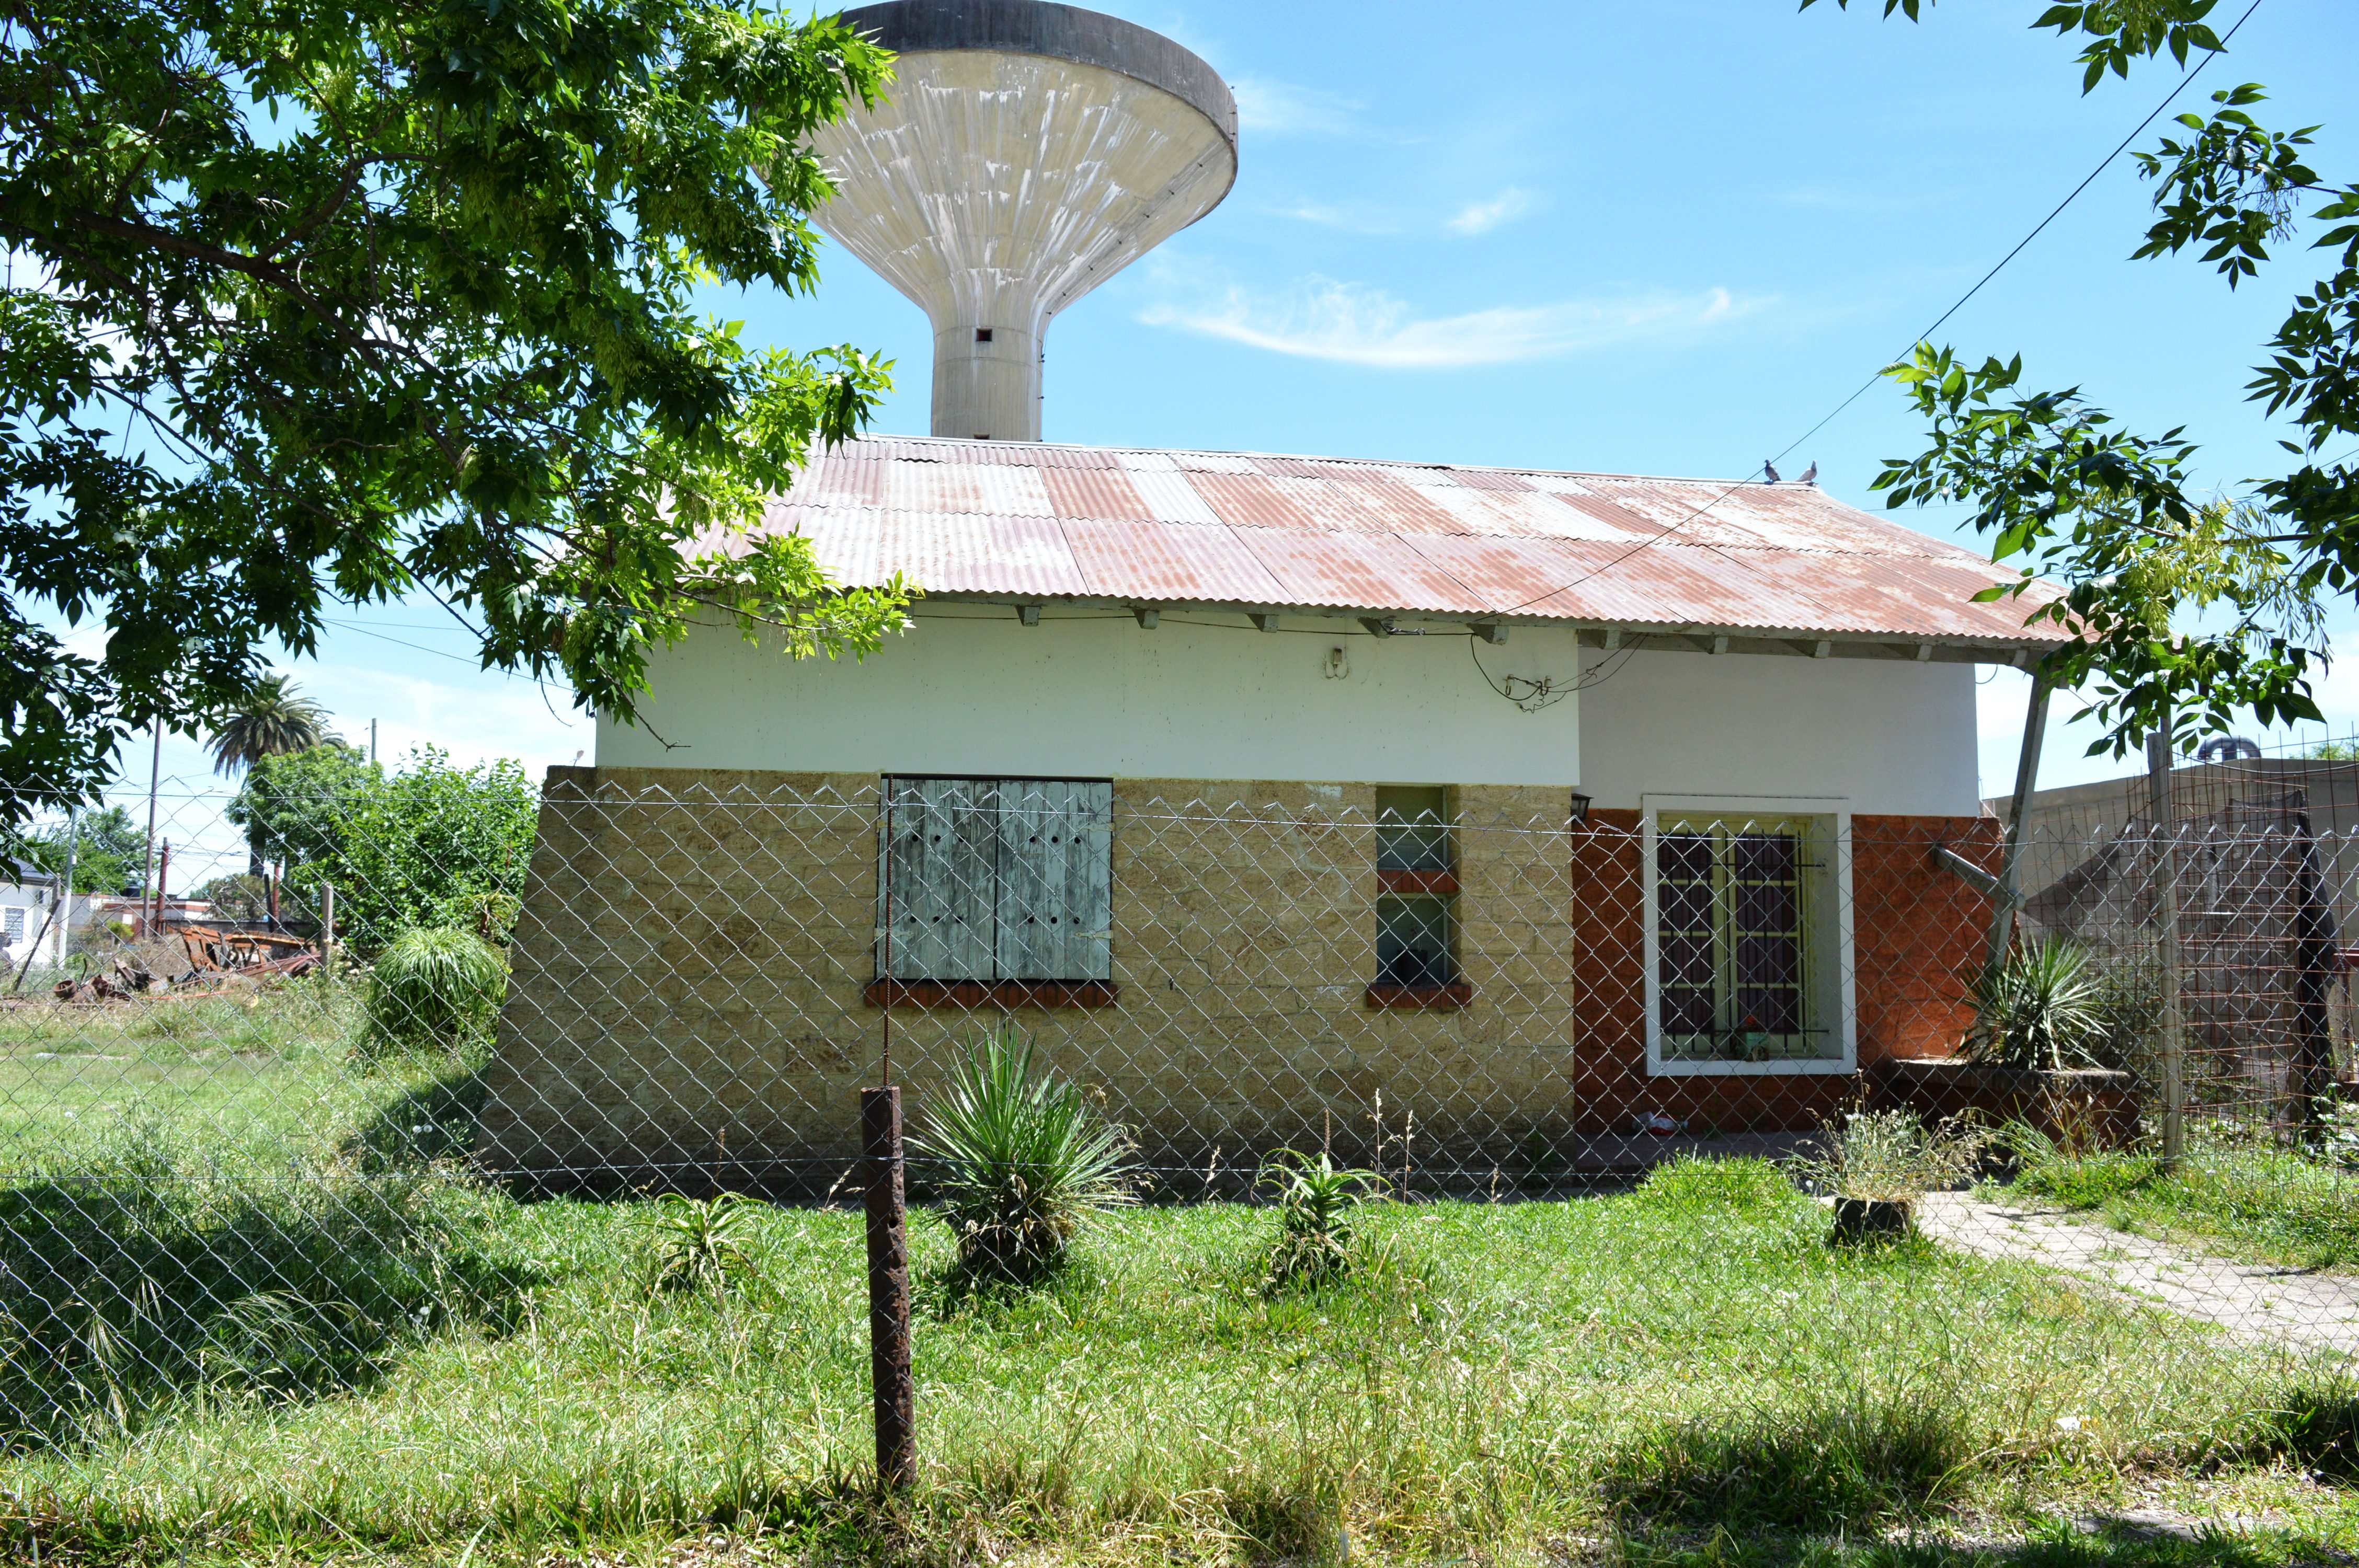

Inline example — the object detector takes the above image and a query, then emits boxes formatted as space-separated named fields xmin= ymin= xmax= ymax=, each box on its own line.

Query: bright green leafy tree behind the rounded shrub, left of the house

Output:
xmin=318 ymin=747 xmax=540 ymax=953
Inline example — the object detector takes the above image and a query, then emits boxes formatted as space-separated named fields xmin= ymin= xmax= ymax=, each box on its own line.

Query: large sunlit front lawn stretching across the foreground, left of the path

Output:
xmin=0 ymin=986 xmax=2354 ymax=1563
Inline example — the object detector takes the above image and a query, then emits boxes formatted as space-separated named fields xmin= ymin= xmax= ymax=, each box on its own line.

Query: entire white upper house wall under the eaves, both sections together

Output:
xmin=597 ymin=606 xmax=1979 ymax=816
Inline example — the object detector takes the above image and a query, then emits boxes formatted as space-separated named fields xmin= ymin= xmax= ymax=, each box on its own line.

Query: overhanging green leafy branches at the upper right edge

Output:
xmin=1802 ymin=0 xmax=2359 ymax=755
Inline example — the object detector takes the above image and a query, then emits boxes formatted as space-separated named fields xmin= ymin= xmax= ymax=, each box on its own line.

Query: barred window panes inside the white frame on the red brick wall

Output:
xmin=1654 ymin=818 xmax=1842 ymax=1061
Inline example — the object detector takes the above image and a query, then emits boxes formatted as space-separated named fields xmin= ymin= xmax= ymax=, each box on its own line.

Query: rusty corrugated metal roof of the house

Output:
xmin=762 ymin=436 xmax=2059 ymax=649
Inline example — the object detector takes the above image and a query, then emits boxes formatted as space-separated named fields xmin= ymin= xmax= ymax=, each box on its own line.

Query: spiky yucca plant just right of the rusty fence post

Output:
xmin=908 ymin=1025 xmax=1137 ymax=1283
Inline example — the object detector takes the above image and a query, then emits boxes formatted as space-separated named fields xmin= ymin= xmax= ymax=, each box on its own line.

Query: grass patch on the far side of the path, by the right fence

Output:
xmin=2010 ymin=1134 xmax=2359 ymax=1269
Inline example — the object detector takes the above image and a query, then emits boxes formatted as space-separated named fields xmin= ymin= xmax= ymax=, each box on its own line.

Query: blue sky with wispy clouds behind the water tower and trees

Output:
xmin=106 ymin=0 xmax=2359 ymax=825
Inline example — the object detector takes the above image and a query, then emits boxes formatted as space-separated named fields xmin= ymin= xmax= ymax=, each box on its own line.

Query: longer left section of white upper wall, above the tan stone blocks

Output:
xmin=597 ymin=606 xmax=1581 ymax=785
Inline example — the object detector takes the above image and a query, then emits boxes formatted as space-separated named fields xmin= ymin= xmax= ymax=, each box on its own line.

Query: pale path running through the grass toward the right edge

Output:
xmin=1918 ymin=1193 xmax=2359 ymax=1353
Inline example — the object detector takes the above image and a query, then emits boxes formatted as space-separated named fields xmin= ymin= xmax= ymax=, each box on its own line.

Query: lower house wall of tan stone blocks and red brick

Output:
xmin=479 ymin=769 xmax=1984 ymax=1193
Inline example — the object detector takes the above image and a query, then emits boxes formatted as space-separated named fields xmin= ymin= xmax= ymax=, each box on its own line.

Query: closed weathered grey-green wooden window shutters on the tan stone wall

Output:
xmin=877 ymin=778 xmax=1114 ymax=981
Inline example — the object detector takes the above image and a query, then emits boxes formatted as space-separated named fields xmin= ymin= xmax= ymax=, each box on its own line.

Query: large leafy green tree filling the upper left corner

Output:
xmin=0 ymin=0 xmax=906 ymax=835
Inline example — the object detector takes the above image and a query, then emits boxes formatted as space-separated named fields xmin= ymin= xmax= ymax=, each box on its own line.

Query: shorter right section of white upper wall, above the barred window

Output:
xmin=1581 ymin=651 xmax=1982 ymax=816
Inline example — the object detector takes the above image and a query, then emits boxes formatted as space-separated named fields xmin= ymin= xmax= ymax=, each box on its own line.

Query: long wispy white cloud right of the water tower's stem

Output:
xmin=1139 ymin=278 xmax=1767 ymax=370
